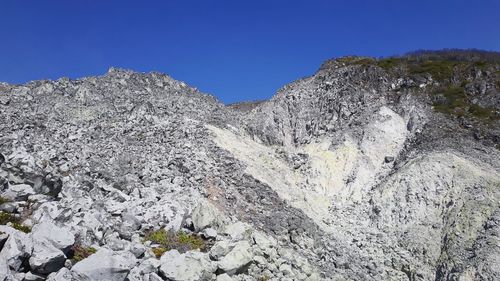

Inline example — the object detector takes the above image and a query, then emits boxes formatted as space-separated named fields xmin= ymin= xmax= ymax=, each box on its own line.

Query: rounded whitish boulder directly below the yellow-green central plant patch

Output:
xmin=160 ymin=250 xmax=217 ymax=281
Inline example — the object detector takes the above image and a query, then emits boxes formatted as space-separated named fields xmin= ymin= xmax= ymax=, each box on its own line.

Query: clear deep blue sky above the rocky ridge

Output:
xmin=0 ymin=0 xmax=500 ymax=103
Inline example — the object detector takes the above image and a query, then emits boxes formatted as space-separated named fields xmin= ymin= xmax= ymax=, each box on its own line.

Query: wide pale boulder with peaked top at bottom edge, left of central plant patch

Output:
xmin=71 ymin=248 xmax=136 ymax=281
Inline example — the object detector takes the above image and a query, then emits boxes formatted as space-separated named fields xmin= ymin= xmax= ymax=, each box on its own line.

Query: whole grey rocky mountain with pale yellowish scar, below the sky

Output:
xmin=0 ymin=50 xmax=500 ymax=281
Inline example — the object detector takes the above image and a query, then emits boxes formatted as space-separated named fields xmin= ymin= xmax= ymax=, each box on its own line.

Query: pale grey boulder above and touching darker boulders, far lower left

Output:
xmin=32 ymin=221 xmax=75 ymax=253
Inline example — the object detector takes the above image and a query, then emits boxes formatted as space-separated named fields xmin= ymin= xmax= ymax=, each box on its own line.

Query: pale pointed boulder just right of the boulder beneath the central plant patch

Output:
xmin=217 ymin=241 xmax=253 ymax=275
